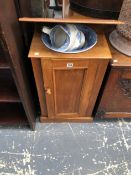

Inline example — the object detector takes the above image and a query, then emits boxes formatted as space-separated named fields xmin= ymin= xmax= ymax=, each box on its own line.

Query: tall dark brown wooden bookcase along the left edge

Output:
xmin=0 ymin=0 xmax=36 ymax=129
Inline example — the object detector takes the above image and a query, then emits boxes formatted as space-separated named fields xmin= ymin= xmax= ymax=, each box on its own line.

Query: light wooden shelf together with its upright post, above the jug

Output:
xmin=19 ymin=0 xmax=124 ymax=25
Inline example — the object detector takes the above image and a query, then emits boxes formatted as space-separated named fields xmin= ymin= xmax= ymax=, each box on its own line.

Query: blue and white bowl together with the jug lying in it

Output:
xmin=42 ymin=24 xmax=97 ymax=53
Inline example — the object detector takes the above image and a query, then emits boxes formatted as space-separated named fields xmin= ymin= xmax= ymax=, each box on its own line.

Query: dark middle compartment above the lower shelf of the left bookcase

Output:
xmin=0 ymin=70 xmax=20 ymax=102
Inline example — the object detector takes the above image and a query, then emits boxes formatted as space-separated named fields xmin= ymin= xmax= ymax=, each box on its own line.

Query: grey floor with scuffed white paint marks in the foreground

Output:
xmin=0 ymin=120 xmax=131 ymax=175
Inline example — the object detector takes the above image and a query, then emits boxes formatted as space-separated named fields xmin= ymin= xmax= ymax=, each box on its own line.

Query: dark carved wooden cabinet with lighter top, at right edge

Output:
xmin=96 ymin=47 xmax=131 ymax=118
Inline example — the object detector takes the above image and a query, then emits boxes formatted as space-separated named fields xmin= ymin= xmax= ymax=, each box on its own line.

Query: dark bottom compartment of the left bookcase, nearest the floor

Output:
xmin=0 ymin=103 xmax=28 ymax=126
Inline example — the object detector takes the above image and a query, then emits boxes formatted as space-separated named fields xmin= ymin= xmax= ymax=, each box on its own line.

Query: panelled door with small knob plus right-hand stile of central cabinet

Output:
xmin=42 ymin=59 xmax=107 ymax=118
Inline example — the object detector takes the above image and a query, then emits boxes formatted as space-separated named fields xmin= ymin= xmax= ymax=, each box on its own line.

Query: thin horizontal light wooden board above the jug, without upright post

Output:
xmin=19 ymin=15 xmax=124 ymax=25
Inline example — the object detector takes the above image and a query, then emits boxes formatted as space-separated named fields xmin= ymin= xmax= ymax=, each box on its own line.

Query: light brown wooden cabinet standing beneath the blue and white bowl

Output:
xmin=29 ymin=32 xmax=111 ymax=121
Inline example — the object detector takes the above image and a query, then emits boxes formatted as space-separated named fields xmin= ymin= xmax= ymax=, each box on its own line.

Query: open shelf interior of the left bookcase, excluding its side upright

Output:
xmin=0 ymin=43 xmax=28 ymax=126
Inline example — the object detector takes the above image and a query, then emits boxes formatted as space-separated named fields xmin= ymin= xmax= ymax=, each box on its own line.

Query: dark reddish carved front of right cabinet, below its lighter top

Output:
xmin=96 ymin=68 xmax=131 ymax=118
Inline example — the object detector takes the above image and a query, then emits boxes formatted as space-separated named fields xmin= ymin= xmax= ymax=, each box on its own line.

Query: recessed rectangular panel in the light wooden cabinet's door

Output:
xmin=53 ymin=69 xmax=86 ymax=113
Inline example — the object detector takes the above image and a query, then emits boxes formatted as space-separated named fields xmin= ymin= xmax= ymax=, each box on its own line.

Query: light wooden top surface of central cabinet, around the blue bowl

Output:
xmin=28 ymin=28 xmax=112 ymax=59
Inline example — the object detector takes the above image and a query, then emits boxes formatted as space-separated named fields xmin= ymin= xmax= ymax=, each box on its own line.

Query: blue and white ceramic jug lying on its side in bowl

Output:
xmin=42 ymin=24 xmax=85 ymax=52
